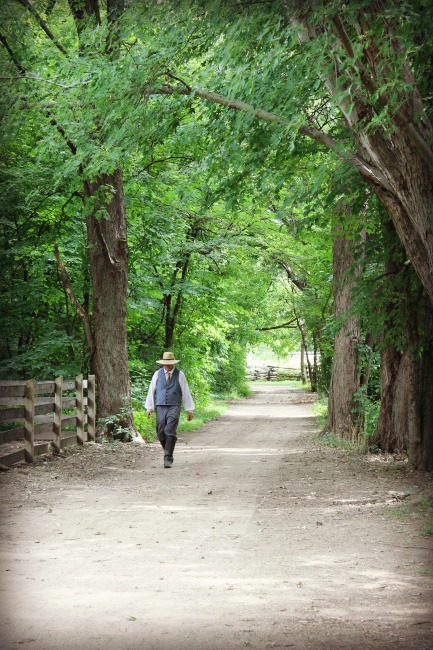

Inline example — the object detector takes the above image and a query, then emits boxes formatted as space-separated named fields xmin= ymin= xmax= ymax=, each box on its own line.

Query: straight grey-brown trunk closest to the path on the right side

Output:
xmin=325 ymin=235 xmax=360 ymax=441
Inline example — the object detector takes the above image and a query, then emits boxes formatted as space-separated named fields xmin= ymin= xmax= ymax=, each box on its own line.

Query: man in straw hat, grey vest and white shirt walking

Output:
xmin=144 ymin=352 xmax=195 ymax=469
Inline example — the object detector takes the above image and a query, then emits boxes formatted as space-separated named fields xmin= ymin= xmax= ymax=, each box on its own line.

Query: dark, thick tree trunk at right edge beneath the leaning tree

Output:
xmin=374 ymin=222 xmax=433 ymax=470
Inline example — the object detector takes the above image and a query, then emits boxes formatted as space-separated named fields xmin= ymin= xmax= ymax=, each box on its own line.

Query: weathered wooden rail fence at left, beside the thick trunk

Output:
xmin=0 ymin=375 xmax=96 ymax=466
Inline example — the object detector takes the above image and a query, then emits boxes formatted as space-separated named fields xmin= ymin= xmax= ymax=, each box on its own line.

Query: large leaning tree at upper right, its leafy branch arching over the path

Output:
xmin=143 ymin=1 xmax=433 ymax=466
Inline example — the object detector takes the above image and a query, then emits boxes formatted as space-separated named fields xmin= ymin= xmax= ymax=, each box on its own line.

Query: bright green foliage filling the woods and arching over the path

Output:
xmin=0 ymin=0 xmax=432 ymax=460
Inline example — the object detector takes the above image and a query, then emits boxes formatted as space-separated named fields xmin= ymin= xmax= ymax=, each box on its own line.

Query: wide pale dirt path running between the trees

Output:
xmin=0 ymin=384 xmax=433 ymax=650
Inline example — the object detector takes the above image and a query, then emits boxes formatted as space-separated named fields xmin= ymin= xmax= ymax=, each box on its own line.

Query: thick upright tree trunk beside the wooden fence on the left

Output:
xmin=85 ymin=169 xmax=135 ymax=434
